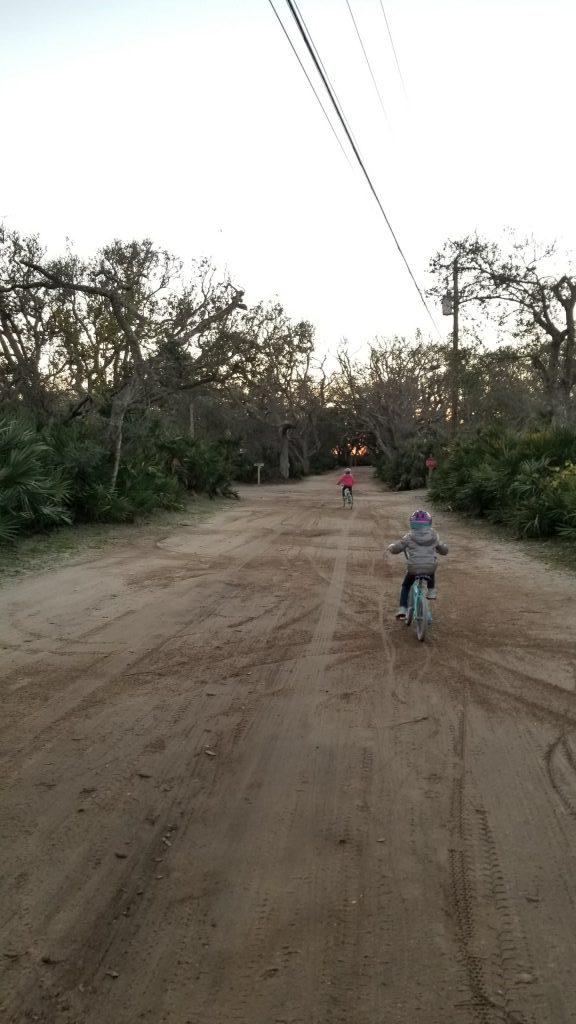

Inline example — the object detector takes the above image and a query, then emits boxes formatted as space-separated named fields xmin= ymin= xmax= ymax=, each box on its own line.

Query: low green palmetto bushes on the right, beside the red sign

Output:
xmin=430 ymin=428 xmax=576 ymax=539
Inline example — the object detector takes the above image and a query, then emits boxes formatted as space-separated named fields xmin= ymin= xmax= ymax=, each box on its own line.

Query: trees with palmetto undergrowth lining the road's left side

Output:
xmin=0 ymin=232 xmax=338 ymax=541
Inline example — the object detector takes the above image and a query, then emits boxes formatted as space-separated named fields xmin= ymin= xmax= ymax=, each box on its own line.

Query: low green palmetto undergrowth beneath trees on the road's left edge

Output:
xmin=0 ymin=413 xmax=234 ymax=543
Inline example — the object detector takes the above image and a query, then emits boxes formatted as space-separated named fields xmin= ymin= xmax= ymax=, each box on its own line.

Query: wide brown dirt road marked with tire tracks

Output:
xmin=0 ymin=471 xmax=576 ymax=1024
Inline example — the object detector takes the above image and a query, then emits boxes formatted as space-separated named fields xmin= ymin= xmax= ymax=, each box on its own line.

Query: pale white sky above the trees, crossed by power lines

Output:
xmin=0 ymin=0 xmax=576 ymax=360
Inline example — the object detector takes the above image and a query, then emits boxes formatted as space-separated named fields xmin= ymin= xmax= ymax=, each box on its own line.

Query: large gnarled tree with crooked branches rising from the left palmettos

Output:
xmin=0 ymin=234 xmax=245 ymax=485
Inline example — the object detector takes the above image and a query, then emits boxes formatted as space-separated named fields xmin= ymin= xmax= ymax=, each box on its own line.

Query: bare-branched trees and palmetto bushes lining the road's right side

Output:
xmin=422 ymin=237 xmax=576 ymax=541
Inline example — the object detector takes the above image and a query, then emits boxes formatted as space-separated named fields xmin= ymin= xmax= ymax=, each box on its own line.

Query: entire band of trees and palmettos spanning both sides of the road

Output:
xmin=0 ymin=225 xmax=576 ymax=541
